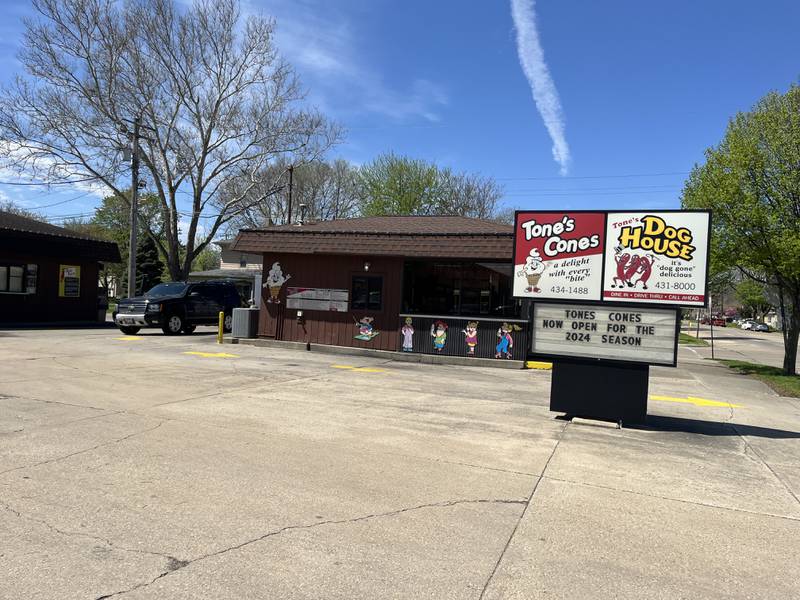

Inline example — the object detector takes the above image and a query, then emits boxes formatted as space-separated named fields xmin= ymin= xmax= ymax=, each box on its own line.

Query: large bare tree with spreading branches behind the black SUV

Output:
xmin=0 ymin=0 xmax=340 ymax=279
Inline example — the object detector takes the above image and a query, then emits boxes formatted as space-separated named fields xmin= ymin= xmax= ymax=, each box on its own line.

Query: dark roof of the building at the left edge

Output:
xmin=0 ymin=211 xmax=121 ymax=262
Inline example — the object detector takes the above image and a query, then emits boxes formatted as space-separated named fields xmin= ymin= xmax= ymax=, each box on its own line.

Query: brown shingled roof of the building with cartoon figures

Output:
xmin=232 ymin=216 xmax=513 ymax=260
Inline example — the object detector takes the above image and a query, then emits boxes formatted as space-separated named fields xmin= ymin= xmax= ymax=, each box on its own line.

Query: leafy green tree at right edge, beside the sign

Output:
xmin=682 ymin=85 xmax=800 ymax=375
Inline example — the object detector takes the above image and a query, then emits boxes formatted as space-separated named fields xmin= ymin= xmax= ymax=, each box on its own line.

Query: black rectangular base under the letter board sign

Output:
xmin=550 ymin=359 xmax=650 ymax=423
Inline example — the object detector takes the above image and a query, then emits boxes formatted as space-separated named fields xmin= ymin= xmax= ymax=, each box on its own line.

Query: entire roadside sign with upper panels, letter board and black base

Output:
xmin=514 ymin=211 xmax=711 ymax=423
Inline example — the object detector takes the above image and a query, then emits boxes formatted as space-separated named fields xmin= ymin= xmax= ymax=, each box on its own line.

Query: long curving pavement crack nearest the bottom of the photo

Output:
xmin=96 ymin=498 xmax=529 ymax=600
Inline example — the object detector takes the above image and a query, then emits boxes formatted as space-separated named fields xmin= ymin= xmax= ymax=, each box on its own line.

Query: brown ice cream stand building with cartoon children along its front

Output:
xmin=232 ymin=216 xmax=527 ymax=359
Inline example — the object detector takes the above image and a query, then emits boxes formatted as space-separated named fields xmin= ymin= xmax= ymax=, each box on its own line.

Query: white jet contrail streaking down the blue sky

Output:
xmin=511 ymin=0 xmax=570 ymax=175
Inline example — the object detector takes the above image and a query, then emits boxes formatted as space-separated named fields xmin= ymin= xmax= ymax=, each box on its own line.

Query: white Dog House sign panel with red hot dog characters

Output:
xmin=603 ymin=211 xmax=710 ymax=306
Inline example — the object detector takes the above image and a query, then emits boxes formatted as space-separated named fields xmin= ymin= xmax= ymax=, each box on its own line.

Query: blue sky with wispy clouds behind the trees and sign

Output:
xmin=0 ymin=0 xmax=800 ymax=224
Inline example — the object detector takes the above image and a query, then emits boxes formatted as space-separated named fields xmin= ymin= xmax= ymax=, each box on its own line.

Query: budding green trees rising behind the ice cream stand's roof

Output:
xmin=359 ymin=153 xmax=503 ymax=219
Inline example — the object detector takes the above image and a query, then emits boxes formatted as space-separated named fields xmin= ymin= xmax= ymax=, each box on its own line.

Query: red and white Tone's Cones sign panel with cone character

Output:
xmin=514 ymin=211 xmax=606 ymax=300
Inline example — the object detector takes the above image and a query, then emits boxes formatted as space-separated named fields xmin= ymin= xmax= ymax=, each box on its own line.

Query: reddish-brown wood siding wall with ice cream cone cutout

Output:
xmin=258 ymin=254 xmax=403 ymax=350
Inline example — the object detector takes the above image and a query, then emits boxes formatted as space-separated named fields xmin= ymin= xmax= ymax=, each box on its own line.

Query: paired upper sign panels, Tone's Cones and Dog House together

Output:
xmin=514 ymin=211 xmax=711 ymax=306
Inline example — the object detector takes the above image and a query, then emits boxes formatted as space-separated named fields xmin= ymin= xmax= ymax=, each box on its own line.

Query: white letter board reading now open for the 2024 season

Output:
xmin=531 ymin=303 xmax=679 ymax=366
